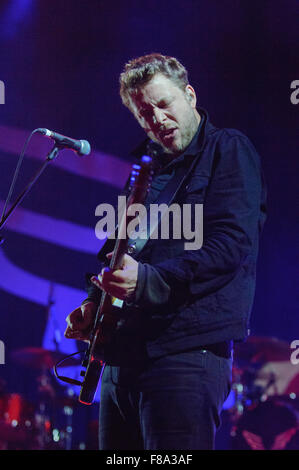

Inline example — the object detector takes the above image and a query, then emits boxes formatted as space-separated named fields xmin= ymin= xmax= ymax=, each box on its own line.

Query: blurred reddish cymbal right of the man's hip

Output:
xmin=234 ymin=336 xmax=291 ymax=364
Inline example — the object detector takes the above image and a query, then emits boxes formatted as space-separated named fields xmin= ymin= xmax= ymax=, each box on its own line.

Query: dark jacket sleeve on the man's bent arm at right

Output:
xmin=135 ymin=134 xmax=262 ymax=307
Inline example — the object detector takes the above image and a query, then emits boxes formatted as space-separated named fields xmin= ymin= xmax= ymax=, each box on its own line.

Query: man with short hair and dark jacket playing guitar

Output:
xmin=65 ymin=54 xmax=265 ymax=450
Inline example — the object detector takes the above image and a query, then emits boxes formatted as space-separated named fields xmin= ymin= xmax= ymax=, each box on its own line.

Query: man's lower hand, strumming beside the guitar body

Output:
xmin=64 ymin=302 xmax=97 ymax=341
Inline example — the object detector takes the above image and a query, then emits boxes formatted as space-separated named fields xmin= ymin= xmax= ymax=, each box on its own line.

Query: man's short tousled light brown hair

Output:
xmin=119 ymin=53 xmax=189 ymax=109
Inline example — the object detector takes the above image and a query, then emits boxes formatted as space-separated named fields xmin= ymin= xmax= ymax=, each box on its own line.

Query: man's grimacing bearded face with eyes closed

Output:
xmin=131 ymin=73 xmax=200 ymax=156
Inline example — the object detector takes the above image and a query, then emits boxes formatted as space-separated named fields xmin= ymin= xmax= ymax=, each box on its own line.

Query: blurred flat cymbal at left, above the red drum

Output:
xmin=11 ymin=347 xmax=80 ymax=369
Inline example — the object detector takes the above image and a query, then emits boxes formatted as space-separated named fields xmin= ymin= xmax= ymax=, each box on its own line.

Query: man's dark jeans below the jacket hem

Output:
xmin=99 ymin=350 xmax=232 ymax=450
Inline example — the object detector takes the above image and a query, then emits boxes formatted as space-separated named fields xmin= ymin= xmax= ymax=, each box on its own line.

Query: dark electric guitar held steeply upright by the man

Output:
xmin=79 ymin=156 xmax=152 ymax=405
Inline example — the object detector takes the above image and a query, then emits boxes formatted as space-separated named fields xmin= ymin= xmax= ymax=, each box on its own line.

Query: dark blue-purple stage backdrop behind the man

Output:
xmin=0 ymin=0 xmax=299 ymax=450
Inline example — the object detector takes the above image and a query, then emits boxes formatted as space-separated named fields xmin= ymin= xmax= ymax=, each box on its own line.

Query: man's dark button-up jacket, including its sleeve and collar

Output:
xmin=84 ymin=109 xmax=266 ymax=357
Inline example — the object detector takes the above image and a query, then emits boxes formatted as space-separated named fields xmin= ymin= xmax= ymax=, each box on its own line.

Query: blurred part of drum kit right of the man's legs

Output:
xmin=226 ymin=336 xmax=299 ymax=450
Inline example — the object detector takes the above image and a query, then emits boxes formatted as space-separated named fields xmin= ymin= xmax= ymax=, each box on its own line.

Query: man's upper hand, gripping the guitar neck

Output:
xmin=91 ymin=253 xmax=138 ymax=300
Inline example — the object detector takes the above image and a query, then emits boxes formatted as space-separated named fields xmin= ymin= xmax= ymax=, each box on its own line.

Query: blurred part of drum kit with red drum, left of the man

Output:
xmin=0 ymin=347 xmax=86 ymax=450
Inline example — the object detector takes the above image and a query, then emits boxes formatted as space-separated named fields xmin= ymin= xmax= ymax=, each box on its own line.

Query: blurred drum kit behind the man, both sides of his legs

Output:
xmin=0 ymin=336 xmax=299 ymax=450
